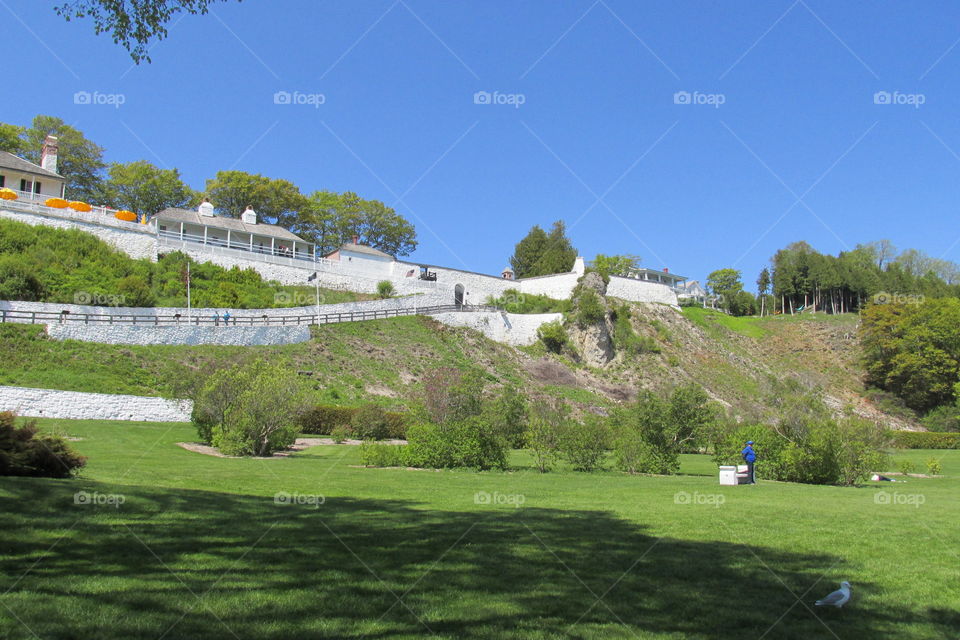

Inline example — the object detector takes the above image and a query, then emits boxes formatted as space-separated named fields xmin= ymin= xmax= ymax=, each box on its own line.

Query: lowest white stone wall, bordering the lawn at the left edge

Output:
xmin=0 ymin=387 xmax=193 ymax=422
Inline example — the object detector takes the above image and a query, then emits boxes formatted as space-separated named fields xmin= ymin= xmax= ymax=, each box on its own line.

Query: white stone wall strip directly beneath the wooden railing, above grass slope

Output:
xmin=47 ymin=324 xmax=310 ymax=346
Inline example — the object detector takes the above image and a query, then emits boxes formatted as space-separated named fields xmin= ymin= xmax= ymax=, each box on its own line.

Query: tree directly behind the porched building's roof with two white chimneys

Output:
xmin=207 ymin=171 xmax=306 ymax=223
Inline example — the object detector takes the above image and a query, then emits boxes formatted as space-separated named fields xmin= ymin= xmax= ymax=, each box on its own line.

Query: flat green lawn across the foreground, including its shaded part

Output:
xmin=0 ymin=420 xmax=960 ymax=640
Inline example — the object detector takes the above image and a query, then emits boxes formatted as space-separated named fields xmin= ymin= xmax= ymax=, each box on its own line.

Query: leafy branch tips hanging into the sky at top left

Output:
xmin=54 ymin=0 xmax=239 ymax=64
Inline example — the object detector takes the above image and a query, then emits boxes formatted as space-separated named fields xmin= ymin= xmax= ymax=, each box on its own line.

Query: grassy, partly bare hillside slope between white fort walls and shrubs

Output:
xmin=0 ymin=304 xmax=911 ymax=428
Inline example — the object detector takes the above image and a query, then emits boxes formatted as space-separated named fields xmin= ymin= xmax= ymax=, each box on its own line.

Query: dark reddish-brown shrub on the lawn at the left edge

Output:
xmin=0 ymin=411 xmax=87 ymax=478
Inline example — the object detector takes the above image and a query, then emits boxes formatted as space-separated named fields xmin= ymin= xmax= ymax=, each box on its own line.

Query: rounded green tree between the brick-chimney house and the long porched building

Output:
xmin=104 ymin=160 xmax=197 ymax=215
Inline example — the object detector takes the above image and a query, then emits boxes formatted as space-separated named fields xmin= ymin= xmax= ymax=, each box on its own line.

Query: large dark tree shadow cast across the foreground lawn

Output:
xmin=0 ymin=479 xmax=944 ymax=640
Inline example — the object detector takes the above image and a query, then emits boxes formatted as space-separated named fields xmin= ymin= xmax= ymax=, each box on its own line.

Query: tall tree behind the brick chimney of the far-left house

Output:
xmin=23 ymin=115 xmax=107 ymax=203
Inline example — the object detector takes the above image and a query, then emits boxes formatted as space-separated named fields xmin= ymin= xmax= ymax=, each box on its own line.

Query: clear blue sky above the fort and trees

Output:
xmin=0 ymin=0 xmax=960 ymax=288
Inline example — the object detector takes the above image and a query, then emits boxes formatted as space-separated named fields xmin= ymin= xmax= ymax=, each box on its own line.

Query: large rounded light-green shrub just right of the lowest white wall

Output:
xmin=194 ymin=360 xmax=312 ymax=456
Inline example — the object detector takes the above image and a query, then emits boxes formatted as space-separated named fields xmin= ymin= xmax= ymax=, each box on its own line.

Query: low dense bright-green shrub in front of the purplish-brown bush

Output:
xmin=405 ymin=416 xmax=507 ymax=470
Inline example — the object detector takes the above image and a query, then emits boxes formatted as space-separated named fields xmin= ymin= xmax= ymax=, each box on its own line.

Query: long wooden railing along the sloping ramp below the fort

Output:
xmin=0 ymin=304 xmax=502 ymax=327
